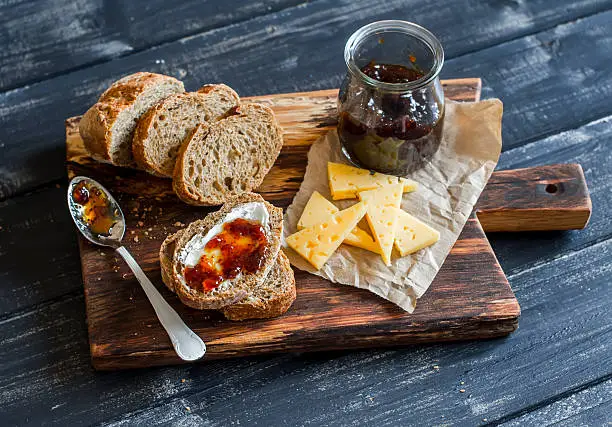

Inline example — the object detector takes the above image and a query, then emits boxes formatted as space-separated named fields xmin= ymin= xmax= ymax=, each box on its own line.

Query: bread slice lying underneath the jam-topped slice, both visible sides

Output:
xmin=159 ymin=234 xmax=296 ymax=320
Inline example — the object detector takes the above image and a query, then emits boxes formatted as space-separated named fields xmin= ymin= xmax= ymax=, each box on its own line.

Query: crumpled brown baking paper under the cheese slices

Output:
xmin=283 ymin=99 xmax=503 ymax=313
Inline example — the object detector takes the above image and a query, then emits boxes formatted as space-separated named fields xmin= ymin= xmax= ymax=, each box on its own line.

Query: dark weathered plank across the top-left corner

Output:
xmin=0 ymin=0 xmax=304 ymax=91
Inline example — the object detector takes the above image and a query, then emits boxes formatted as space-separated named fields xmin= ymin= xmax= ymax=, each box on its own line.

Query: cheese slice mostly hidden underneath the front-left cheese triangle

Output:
xmin=297 ymin=191 xmax=380 ymax=254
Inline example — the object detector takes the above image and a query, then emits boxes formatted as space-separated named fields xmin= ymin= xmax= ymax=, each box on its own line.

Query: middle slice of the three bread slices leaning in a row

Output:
xmin=132 ymin=85 xmax=240 ymax=177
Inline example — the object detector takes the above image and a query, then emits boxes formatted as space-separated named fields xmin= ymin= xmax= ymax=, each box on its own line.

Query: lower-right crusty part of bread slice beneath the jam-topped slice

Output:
xmin=221 ymin=250 xmax=296 ymax=320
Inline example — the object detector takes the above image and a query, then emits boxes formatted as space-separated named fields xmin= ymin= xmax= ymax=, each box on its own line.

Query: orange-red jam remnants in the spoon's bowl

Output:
xmin=72 ymin=181 xmax=116 ymax=235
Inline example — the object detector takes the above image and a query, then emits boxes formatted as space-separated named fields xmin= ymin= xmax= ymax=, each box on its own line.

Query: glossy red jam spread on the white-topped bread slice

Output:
xmin=184 ymin=218 xmax=268 ymax=292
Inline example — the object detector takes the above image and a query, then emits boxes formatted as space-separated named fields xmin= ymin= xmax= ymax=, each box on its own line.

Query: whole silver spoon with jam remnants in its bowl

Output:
xmin=68 ymin=176 xmax=206 ymax=361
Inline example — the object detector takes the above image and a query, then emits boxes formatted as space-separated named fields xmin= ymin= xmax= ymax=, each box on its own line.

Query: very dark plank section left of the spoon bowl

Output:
xmin=0 ymin=186 xmax=81 ymax=319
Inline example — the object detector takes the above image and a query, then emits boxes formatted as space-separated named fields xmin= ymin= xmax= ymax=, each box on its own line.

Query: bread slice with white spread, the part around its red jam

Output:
xmin=167 ymin=193 xmax=283 ymax=310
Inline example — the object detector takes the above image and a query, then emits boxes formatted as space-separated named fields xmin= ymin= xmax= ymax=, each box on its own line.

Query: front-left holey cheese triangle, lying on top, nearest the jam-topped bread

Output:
xmin=286 ymin=203 xmax=366 ymax=270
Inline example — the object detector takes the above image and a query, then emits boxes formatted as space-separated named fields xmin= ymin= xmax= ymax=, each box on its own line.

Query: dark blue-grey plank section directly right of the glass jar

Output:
xmin=443 ymin=11 xmax=612 ymax=150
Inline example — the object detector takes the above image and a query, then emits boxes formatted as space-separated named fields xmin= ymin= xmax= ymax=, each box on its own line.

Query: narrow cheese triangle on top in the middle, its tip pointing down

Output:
xmin=358 ymin=183 xmax=404 ymax=265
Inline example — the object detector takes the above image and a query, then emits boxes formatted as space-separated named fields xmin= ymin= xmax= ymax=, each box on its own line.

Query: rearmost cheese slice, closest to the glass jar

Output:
xmin=327 ymin=162 xmax=418 ymax=200
